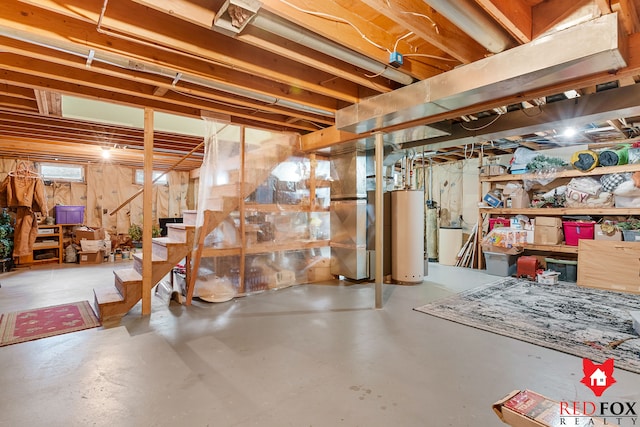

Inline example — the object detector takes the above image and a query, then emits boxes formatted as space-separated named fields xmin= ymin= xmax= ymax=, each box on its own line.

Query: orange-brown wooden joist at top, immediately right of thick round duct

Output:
xmin=476 ymin=0 xmax=533 ymax=43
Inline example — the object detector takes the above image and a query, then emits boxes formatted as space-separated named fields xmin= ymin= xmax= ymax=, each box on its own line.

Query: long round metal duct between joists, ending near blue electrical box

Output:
xmin=250 ymin=14 xmax=413 ymax=85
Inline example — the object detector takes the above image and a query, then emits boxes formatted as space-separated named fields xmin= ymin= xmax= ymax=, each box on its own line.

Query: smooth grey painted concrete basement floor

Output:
xmin=0 ymin=261 xmax=640 ymax=427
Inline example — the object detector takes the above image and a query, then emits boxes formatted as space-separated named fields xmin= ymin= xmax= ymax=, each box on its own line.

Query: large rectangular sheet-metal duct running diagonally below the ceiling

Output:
xmin=336 ymin=14 xmax=627 ymax=134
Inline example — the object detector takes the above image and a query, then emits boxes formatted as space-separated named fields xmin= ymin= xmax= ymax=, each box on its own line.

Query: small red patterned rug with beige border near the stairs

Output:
xmin=0 ymin=301 xmax=100 ymax=347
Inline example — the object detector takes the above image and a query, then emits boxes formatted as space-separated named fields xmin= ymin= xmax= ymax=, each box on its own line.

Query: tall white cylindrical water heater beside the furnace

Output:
xmin=391 ymin=190 xmax=425 ymax=283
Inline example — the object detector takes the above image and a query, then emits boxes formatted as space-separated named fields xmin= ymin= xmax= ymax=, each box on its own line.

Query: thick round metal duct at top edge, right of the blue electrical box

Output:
xmin=424 ymin=0 xmax=514 ymax=53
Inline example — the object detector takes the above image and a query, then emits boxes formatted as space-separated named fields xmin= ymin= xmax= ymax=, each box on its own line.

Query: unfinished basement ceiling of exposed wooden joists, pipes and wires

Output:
xmin=0 ymin=0 xmax=640 ymax=168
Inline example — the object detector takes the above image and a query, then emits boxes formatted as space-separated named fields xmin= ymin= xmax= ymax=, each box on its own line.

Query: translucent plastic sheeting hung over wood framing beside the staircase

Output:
xmin=195 ymin=120 xmax=332 ymax=302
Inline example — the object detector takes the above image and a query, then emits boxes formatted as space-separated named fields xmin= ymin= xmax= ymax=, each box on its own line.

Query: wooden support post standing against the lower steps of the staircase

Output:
xmin=142 ymin=108 xmax=153 ymax=316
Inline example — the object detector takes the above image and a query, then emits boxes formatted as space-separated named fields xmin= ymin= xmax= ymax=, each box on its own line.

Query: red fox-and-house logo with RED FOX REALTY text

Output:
xmin=560 ymin=359 xmax=640 ymax=426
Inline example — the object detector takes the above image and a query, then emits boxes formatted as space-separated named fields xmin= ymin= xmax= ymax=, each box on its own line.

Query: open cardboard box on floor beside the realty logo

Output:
xmin=493 ymin=390 xmax=617 ymax=427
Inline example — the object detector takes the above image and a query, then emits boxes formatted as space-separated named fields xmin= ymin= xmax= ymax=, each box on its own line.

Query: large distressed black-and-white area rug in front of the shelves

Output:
xmin=415 ymin=278 xmax=640 ymax=373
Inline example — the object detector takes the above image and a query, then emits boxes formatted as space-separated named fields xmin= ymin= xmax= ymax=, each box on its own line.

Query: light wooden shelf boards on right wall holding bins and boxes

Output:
xmin=477 ymin=164 xmax=640 ymax=269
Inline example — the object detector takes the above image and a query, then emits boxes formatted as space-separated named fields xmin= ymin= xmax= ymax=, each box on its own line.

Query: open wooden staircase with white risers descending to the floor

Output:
xmin=94 ymin=139 xmax=292 ymax=322
